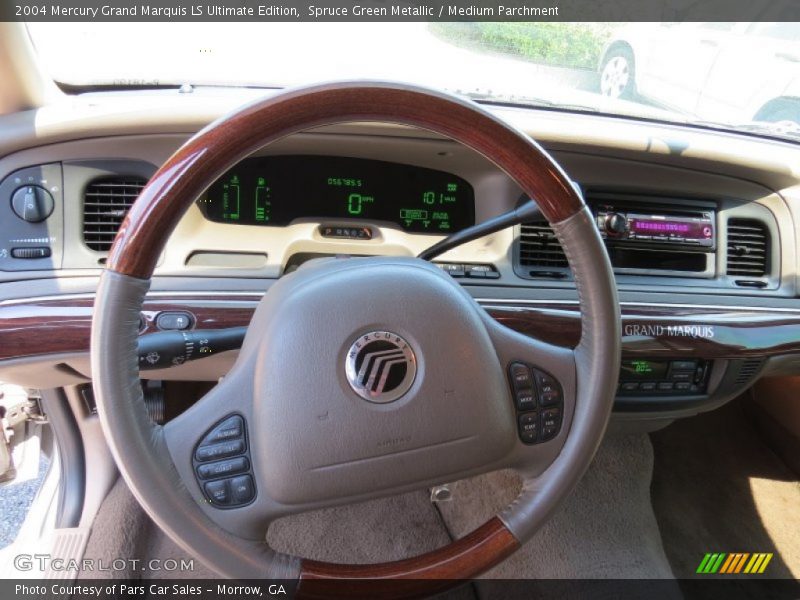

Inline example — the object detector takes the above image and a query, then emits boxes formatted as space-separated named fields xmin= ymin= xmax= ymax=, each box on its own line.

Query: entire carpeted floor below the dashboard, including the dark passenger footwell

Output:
xmin=78 ymin=394 xmax=800 ymax=599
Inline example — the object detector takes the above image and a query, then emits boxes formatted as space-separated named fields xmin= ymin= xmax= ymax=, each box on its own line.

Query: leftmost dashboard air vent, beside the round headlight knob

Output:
xmin=83 ymin=177 xmax=147 ymax=252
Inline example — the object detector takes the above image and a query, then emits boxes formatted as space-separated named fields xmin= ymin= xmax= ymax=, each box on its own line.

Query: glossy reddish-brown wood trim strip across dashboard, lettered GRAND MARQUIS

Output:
xmin=0 ymin=293 xmax=800 ymax=360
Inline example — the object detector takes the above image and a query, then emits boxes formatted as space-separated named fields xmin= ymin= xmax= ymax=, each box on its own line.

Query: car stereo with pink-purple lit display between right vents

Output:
xmin=595 ymin=205 xmax=716 ymax=251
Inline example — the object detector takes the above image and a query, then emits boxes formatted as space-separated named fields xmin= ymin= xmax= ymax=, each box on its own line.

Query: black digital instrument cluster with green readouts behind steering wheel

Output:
xmin=199 ymin=156 xmax=475 ymax=235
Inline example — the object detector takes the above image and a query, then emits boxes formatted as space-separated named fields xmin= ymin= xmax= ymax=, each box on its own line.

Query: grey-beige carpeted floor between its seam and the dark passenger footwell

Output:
xmin=432 ymin=434 xmax=672 ymax=589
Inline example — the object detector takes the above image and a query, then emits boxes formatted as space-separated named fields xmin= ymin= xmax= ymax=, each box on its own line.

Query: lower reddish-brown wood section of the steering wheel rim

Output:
xmin=297 ymin=517 xmax=519 ymax=600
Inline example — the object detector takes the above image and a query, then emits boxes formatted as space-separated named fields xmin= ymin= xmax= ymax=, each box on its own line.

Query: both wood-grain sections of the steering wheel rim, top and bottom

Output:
xmin=93 ymin=82 xmax=618 ymax=598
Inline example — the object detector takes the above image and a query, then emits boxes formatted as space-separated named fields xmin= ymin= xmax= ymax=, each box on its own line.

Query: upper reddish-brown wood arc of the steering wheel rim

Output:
xmin=107 ymin=82 xmax=584 ymax=279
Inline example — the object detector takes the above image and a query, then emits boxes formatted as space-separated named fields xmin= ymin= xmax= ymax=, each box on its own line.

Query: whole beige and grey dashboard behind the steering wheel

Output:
xmin=0 ymin=90 xmax=800 ymax=420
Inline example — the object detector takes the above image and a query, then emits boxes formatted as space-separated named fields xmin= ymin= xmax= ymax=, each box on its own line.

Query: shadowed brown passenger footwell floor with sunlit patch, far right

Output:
xmin=651 ymin=401 xmax=800 ymax=578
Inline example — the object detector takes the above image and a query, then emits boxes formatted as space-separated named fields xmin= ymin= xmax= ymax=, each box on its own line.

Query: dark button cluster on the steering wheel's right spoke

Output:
xmin=508 ymin=361 xmax=564 ymax=444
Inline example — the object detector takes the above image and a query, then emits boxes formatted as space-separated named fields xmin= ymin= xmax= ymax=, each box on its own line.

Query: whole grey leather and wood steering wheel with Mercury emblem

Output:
xmin=91 ymin=82 xmax=621 ymax=598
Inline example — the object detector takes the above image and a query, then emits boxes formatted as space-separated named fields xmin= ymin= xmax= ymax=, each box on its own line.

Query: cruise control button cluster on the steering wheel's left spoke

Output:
xmin=192 ymin=415 xmax=256 ymax=508
